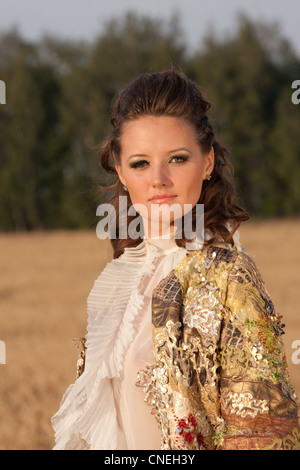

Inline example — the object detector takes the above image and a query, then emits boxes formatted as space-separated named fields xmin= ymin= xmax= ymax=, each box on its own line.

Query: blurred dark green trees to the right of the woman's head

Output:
xmin=189 ymin=17 xmax=300 ymax=217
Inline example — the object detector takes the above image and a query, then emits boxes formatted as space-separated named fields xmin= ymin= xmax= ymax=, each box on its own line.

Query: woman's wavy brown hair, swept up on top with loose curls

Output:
xmin=100 ymin=70 xmax=249 ymax=258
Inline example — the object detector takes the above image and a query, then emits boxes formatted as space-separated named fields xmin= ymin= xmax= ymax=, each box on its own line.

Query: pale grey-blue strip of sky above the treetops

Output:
xmin=0 ymin=0 xmax=300 ymax=55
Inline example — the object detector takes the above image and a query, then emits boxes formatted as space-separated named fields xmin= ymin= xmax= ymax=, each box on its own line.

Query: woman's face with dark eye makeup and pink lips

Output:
xmin=116 ymin=116 xmax=214 ymax=237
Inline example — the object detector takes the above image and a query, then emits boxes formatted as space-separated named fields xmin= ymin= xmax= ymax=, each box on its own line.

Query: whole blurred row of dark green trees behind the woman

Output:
xmin=0 ymin=13 xmax=300 ymax=231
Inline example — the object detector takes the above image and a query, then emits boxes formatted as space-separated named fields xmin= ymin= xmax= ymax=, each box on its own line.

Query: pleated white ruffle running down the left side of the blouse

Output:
xmin=52 ymin=242 xmax=163 ymax=450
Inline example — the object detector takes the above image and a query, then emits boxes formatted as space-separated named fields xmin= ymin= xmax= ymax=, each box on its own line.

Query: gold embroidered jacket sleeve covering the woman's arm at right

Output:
xmin=215 ymin=253 xmax=300 ymax=450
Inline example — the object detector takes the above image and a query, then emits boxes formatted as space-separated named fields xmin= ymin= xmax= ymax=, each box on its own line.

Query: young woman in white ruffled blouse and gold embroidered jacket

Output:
xmin=53 ymin=70 xmax=300 ymax=450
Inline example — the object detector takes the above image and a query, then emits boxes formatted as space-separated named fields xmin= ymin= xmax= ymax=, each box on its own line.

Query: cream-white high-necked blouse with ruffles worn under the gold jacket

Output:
xmin=52 ymin=233 xmax=243 ymax=450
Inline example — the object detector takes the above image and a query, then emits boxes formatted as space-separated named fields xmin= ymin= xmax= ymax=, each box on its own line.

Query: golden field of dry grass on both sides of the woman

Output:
xmin=0 ymin=220 xmax=300 ymax=450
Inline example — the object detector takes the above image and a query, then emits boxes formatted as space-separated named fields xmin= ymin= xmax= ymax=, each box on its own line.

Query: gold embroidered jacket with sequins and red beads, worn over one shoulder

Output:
xmin=137 ymin=243 xmax=300 ymax=450
